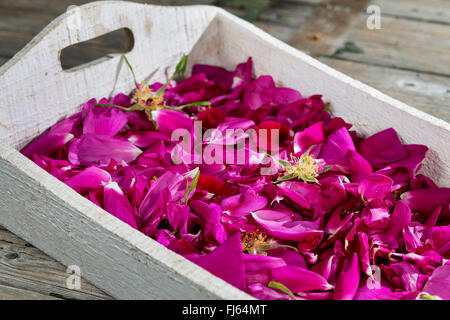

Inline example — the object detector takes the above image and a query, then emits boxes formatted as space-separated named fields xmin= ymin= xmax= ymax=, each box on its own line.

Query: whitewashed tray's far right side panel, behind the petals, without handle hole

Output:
xmin=215 ymin=11 xmax=450 ymax=186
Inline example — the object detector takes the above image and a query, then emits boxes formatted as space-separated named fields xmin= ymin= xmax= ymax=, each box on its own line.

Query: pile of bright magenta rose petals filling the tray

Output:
xmin=22 ymin=59 xmax=450 ymax=299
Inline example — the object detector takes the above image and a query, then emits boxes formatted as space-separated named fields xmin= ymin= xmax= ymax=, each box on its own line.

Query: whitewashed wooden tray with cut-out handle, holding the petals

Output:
xmin=0 ymin=1 xmax=450 ymax=299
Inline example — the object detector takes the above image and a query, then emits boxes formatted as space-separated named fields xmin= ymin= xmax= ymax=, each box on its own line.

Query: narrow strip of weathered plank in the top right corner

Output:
xmin=372 ymin=0 xmax=450 ymax=24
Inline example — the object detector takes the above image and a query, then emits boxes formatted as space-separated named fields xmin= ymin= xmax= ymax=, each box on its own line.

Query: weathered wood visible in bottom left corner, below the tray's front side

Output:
xmin=0 ymin=229 xmax=111 ymax=300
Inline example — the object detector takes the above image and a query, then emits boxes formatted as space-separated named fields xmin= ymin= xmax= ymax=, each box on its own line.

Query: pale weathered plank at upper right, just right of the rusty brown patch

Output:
xmin=330 ymin=15 xmax=450 ymax=76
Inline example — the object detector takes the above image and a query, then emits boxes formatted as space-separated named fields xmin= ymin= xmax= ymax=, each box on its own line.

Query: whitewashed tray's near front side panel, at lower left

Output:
xmin=0 ymin=142 xmax=251 ymax=299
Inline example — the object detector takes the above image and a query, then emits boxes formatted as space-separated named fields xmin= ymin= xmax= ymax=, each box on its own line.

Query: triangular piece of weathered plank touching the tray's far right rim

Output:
xmin=320 ymin=58 xmax=450 ymax=122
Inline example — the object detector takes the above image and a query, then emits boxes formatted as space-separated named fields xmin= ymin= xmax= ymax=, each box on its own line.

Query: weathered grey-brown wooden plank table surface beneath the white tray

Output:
xmin=0 ymin=0 xmax=450 ymax=299
